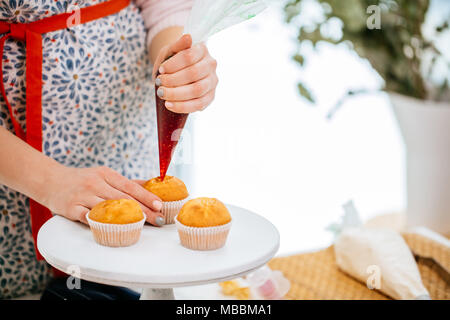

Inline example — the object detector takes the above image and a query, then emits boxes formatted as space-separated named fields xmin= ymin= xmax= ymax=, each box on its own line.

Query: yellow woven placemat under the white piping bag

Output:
xmin=269 ymin=235 xmax=450 ymax=300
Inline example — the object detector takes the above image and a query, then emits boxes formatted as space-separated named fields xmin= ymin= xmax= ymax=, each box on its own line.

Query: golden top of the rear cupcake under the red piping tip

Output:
xmin=144 ymin=176 xmax=189 ymax=201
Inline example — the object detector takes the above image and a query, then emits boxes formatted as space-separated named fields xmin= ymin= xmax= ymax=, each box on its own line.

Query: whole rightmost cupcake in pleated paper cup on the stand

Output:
xmin=175 ymin=198 xmax=231 ymax=250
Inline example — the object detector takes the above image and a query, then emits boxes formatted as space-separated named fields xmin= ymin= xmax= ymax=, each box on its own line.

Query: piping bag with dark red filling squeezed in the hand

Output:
xmin=155 ymin=0 xmax=267 ymax=180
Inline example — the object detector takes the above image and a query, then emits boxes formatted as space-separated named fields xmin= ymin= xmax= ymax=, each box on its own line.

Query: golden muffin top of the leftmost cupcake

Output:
xmin=89 ymin=199 xmax=144 ymax=224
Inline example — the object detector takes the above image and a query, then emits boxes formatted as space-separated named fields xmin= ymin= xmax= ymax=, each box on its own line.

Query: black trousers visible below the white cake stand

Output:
xmin=41 ymin=277 xmax=140 ymax=300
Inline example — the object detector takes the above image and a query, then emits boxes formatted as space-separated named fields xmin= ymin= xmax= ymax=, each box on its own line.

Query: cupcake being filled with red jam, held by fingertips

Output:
xmin=144 ymin=176 xmax=189 ymax=224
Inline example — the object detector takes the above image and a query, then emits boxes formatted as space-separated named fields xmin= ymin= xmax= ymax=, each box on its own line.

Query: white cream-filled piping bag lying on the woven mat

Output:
xmin=329 ymin=201 xmax=430 ymax=300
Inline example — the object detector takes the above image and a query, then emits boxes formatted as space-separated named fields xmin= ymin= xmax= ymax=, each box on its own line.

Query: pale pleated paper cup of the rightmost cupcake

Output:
xmin=175 ymin=217 xmax=232 ymax=250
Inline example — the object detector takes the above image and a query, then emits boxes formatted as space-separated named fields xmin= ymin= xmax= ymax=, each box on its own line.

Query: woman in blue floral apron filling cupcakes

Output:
xmin=0 ymin=0 xmax=217 ymax=298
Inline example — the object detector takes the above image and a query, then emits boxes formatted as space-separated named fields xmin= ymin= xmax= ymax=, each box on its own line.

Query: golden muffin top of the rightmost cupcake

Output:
xmin=177 ymin=197 xmax=231 ymax=227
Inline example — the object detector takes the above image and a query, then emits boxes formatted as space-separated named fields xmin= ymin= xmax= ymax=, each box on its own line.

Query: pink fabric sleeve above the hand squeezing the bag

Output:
xmin=135 ymin=0 xmax=194 ymax=45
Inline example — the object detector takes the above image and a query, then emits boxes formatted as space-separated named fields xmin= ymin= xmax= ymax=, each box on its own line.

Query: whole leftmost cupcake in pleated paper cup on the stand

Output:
xmin=86 ymin=199 xmax=145 ymax=247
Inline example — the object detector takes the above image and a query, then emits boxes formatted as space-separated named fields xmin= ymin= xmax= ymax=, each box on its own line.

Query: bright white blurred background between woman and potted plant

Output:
xmin=174 ymin=0 xmax=450 ymax=254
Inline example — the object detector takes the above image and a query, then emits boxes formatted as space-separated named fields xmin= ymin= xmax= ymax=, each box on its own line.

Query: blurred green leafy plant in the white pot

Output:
xmin=284 ymin=0 xmax=450 ymax=102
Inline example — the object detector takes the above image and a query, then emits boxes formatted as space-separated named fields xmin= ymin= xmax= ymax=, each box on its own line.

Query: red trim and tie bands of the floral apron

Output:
xmin=0 ymin=0 xmax=130 ymax=260
